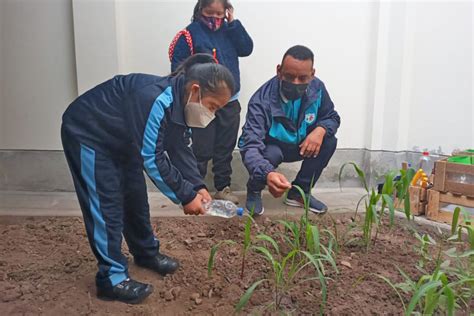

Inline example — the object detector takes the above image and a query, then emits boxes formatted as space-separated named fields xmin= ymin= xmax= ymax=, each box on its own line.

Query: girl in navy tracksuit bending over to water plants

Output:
xmin=61 ymin=54 xmax=234 ymax=303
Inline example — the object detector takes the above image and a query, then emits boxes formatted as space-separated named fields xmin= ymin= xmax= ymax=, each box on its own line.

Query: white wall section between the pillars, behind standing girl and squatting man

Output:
xmin=116 ymin=0 xmax=377 ymax=148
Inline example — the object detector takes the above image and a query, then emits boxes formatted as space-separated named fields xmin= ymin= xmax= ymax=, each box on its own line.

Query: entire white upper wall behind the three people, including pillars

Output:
xmin=0 ymin=0 xmax=474 ymax=153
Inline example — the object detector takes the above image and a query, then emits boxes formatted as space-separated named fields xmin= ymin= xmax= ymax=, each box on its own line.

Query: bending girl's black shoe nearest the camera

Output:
xmin=97 ymin=278 xmax=153 ymax=304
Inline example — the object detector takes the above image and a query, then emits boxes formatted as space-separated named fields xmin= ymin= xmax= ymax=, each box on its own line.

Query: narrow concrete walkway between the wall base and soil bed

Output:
xmin=0 ymin=188 xmax=364 ymax=217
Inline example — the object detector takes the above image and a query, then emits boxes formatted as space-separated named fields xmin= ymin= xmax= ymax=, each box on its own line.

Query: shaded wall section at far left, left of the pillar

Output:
xmin=0 ymin=0 xmax=77 ymax=149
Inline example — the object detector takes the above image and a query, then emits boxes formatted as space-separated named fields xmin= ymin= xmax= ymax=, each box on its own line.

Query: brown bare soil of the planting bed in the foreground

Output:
xmin=0 ymin=214 xmax=473 ymax=315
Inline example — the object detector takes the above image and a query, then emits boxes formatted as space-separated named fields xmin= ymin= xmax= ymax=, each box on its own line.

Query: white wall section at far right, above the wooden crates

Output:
xmin=405 ymin=2 xmax=474 ymax=151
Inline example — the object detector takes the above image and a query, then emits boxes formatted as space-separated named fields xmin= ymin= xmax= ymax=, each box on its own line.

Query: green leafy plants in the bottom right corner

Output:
xmin=378 ymin=207 xmax=474 ymax=316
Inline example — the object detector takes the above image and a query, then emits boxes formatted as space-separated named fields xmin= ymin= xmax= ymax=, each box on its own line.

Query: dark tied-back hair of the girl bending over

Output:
xmin=171 ymin=54 xmax=235 ymax=95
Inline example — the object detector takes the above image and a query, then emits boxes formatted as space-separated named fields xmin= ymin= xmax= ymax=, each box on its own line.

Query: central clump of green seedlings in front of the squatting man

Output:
xmin=208 ymin=187 xmax=338 ymax=314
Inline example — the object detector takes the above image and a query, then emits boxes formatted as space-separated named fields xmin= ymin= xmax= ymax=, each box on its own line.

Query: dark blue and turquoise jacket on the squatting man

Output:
xmin=239 ymin=77 xmax=341 ymax=181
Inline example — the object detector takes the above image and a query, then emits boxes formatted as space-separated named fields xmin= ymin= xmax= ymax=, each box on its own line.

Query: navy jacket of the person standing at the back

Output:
xmin=171 ymin=20 xmax=253 ymax=94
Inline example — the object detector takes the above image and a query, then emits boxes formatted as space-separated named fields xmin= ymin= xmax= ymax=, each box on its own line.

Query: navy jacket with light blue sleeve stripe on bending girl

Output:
xmin=63 ymin=74 xmax=205 ymax=204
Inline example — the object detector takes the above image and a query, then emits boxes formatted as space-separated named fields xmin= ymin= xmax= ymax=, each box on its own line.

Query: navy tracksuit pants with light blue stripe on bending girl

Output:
xmin=61 ymin=127 xmax=159 ymax=286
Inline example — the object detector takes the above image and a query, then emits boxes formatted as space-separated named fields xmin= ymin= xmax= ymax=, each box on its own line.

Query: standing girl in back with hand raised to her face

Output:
xmin=169 ymin=0 xmax=253 ymax=203
